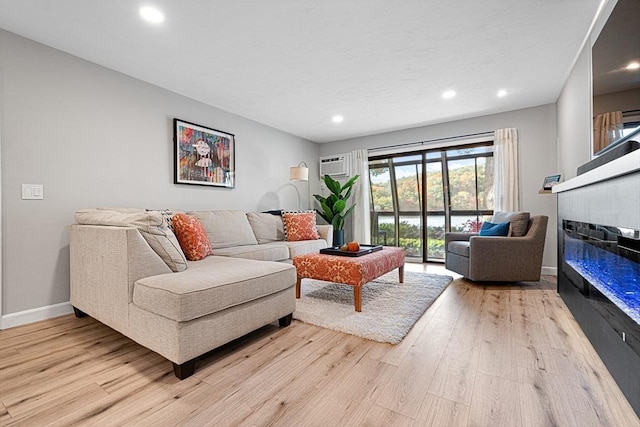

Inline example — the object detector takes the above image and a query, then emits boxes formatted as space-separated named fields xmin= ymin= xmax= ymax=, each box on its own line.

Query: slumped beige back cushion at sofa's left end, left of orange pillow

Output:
xmin=75 ymin=208 xmax=187 ymax=272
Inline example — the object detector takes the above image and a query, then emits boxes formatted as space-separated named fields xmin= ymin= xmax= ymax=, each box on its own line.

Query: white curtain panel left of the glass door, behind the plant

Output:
xmin=351 ymin=148 xmax=371 ymax=244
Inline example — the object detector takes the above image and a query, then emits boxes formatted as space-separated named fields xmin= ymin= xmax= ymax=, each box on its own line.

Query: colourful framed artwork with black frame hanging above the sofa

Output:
xmin=173 ymin=119 xmax=235 ymax=188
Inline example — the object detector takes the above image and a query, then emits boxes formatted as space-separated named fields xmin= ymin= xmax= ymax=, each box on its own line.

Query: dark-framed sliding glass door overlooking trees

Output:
xmin=369 ymin=142 xmax=493 ymax=261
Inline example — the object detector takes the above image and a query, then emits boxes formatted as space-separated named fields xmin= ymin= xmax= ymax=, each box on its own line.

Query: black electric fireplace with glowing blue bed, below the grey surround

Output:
xmin=558 ymin=219 xmax=640 ymax=413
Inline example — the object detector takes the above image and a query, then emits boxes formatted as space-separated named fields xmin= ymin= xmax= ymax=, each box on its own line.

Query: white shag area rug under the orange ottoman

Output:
xmin=293 ymin=270 xmax=453 ymax=344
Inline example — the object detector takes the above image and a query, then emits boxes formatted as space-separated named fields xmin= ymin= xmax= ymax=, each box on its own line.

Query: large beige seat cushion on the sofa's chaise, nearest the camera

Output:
xmin=133 ymin=256 xmax=296 ymax=322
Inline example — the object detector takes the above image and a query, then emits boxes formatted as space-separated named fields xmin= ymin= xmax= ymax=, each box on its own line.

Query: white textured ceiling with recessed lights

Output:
xmin=0 ymin=0 xmax=600 ymax=142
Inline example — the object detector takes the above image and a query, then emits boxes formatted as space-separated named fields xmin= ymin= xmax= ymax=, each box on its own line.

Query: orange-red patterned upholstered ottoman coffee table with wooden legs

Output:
xmin=293 ymin=246 xmax=404 ymax=311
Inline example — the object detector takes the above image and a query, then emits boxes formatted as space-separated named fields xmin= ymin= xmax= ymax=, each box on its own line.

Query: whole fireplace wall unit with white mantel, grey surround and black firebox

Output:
xmin=553 ymin=161 xmax=640 ymax=415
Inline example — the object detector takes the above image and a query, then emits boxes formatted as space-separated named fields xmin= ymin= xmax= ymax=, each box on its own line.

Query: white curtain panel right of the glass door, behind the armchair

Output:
xmin=493 ymin=128 xmax=520 ymax=212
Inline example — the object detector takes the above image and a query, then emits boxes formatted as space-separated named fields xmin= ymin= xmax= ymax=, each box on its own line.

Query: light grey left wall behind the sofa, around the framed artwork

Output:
xmin=0 ymin=30 xmax=318 ymax=315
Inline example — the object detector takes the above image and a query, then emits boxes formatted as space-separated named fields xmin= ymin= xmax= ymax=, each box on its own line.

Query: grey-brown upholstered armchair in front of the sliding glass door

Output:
xmin=445 ymin=215 xmax=549 ymax=282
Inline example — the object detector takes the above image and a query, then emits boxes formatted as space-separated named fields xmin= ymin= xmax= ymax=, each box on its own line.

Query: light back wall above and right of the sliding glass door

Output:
xmin=320 ymin=104 xmax=558 ymax=273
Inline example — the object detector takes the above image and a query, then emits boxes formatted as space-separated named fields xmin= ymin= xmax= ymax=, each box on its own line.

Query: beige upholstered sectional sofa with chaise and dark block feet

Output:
xmin=70 ymin=209 xmax=332 ymax=379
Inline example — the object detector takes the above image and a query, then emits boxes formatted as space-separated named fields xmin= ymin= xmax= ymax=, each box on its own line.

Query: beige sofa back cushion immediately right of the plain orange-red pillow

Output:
xmin=187 ymin=210 xmax=258 ymax=249
